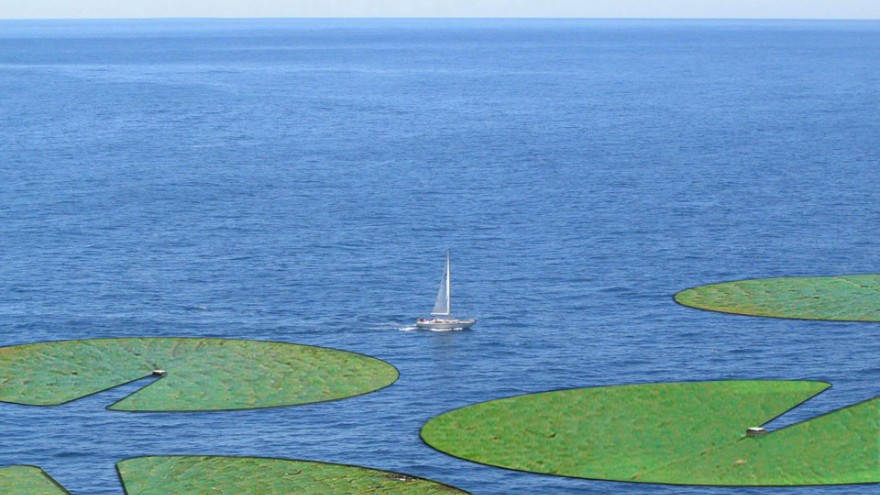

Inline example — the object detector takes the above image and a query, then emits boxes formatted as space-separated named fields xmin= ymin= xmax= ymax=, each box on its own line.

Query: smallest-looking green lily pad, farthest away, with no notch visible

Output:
xmin=675 ymin=274 xmax=880 ymax=321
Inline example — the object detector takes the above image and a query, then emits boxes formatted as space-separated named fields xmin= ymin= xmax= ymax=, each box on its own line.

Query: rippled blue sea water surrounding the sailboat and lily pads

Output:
xmin=0 ymin=19 xmax=880 ymax=495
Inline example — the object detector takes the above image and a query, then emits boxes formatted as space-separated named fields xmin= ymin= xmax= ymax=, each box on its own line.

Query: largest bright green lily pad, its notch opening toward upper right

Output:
xmin=421 ymin=381 xmax=880 ymax=486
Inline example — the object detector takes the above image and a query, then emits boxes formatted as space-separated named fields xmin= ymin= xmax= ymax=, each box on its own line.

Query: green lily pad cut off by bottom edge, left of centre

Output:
xmin=117 ymin=456 xmax=467 ymax=495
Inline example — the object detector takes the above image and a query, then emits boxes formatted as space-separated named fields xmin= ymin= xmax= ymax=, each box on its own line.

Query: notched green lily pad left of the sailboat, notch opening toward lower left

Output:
xmin=0 ymin=338 xmax=398 ymax=412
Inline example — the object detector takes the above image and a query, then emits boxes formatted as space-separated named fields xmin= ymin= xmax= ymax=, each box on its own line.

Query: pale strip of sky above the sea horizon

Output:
xmin=0 ymin=0 xmax=880 ymax=19
